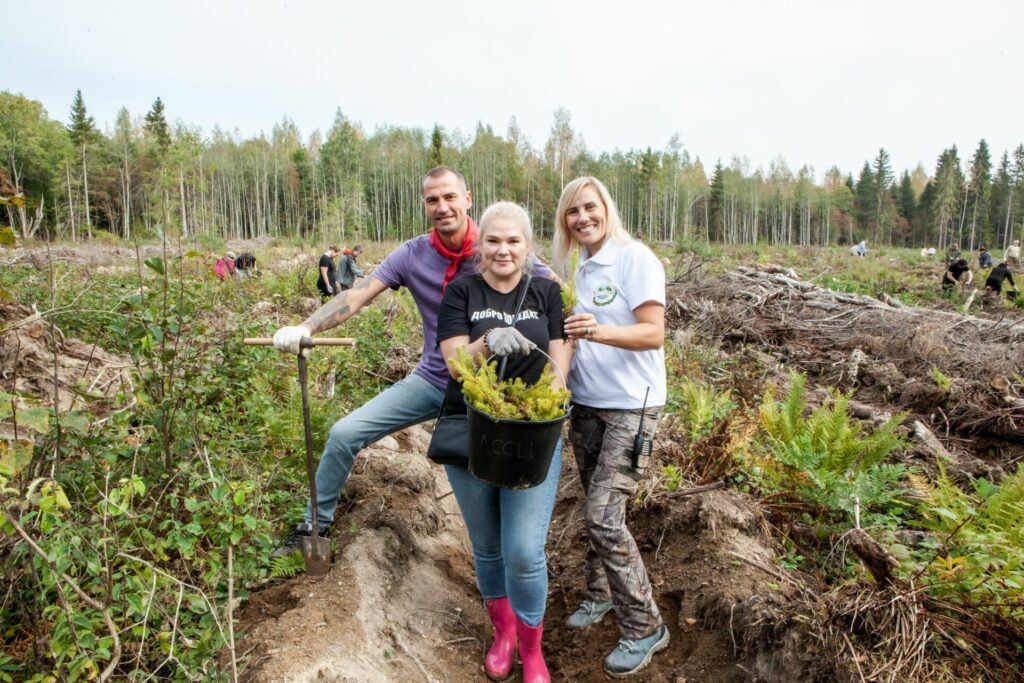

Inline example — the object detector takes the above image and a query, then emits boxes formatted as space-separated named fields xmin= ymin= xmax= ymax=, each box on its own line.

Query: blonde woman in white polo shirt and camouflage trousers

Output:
xmin=554 ymin=177 xmax=669 ymax=677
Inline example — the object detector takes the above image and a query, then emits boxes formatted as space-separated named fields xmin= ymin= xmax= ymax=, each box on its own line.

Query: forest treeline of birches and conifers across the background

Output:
xmin=0 ymin=91 xmax=1024 ymax=250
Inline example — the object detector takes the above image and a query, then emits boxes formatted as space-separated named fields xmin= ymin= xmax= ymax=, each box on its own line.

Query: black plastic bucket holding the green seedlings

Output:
xmin=466 ymin=401 xmax=568 ymax=488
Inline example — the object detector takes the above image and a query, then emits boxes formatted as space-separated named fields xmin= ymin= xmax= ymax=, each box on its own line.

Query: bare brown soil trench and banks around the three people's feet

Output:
xmin=238 ymin=427 xmax=835 ymax=683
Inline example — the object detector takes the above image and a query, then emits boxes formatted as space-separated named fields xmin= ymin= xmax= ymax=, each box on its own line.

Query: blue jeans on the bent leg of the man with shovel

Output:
xmin=306 ymin=375 xmax=444 ymax=526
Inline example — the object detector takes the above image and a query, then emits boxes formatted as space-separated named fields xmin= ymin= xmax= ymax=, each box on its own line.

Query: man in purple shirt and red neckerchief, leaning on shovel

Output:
xmin=272 ymin=166 xmax=551 ymax=557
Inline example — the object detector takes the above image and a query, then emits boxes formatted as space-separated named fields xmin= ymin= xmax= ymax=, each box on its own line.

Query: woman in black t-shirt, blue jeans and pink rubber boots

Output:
xmin=437 ymin=202 xmax=572 ymax=681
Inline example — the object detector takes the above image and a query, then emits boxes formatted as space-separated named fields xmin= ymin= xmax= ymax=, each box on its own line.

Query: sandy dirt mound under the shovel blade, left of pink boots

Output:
xmin=239 ymin=428 xmax=487 ymax=683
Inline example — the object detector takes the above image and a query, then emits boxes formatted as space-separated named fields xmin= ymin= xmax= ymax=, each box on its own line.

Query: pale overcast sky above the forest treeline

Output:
xmin=8 ymin=0 xmax=1024 ymax=179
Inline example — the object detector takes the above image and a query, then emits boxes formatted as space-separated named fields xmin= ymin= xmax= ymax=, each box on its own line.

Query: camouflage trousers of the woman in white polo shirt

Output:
xmin=569 ymin=404 xmax=663 ymax=640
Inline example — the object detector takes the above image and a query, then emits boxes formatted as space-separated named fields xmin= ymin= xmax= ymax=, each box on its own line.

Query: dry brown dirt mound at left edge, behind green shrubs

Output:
xmin=0 ymin=304 xmax=134 ymax=416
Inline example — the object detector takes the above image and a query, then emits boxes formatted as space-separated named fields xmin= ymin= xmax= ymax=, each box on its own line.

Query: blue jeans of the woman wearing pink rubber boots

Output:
xmin=444 ymin=438 xmax=562 ymax=627
